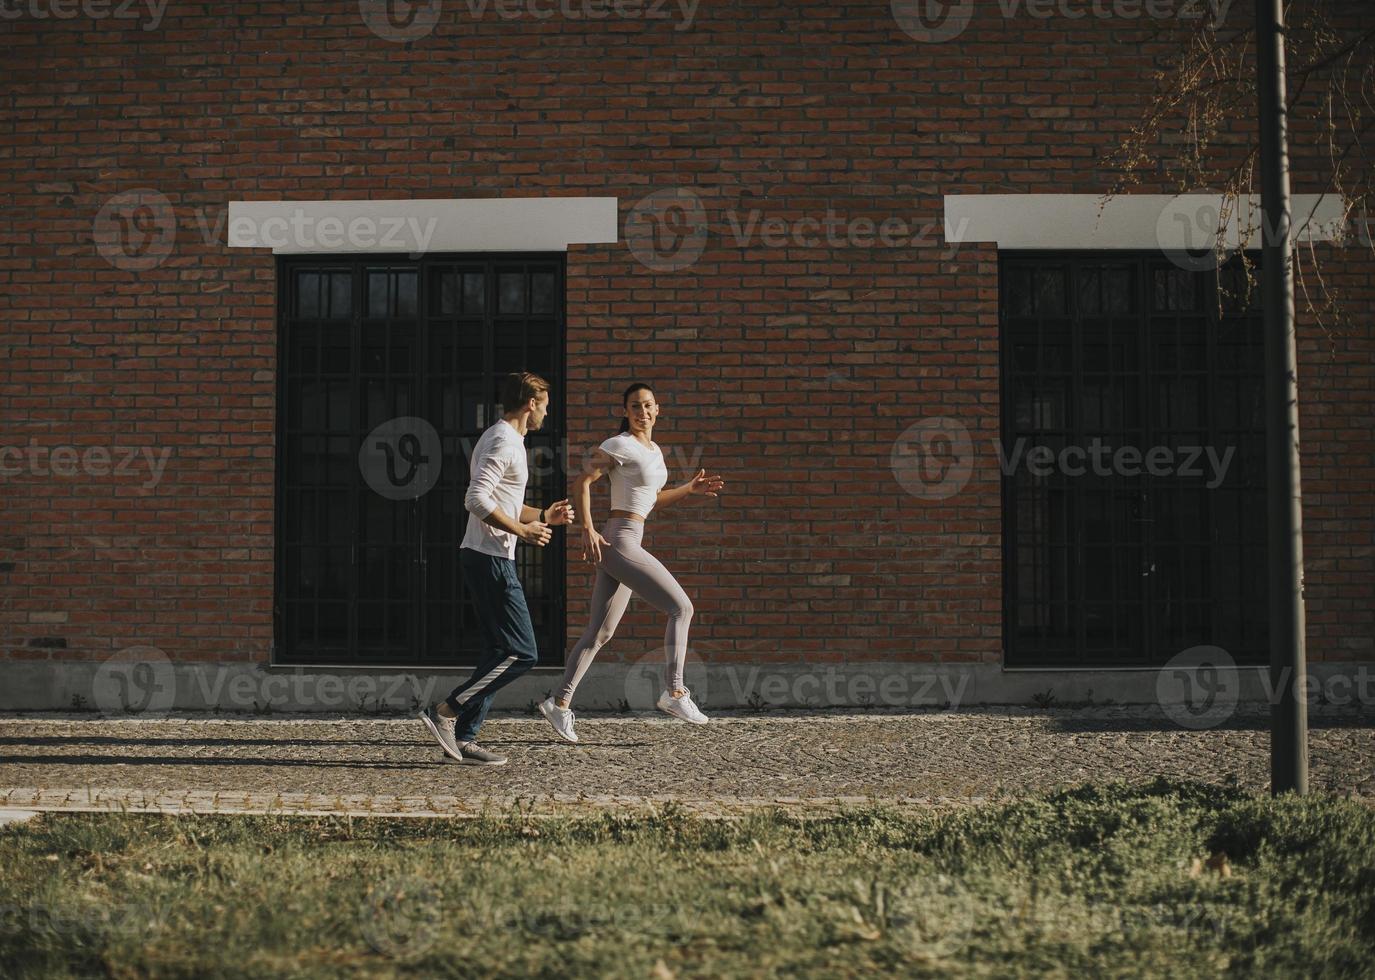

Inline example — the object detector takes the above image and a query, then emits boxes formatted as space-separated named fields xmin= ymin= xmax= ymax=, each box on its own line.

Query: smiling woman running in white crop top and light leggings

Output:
xmin=539 ymin=383 xmax=725 ymax=742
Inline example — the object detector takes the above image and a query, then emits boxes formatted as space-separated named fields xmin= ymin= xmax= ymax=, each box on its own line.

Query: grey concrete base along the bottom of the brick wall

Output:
xmin=0 ymin=647 xmax=1375 ymax=716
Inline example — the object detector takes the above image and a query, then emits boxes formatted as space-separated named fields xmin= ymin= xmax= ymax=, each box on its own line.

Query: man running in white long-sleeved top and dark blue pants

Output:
xmin=421 ymin=371 xmax=573 ymax=766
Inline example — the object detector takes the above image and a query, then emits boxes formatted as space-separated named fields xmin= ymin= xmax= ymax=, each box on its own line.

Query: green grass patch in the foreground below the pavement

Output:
xmin=0 ymin=779 xmax=1375 ymax=979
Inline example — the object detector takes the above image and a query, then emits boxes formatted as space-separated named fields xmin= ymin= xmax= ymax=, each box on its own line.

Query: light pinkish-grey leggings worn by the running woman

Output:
xmin=554 ymin=517 xmax=693 ymax=701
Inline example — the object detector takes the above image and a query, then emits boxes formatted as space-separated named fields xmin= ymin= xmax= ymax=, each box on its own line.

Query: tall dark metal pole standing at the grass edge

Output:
xmin=1255 ymin=0 xmax=1308 ymax=796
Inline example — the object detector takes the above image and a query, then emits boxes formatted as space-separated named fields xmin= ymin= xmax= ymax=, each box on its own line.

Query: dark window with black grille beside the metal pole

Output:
xmin=1000 ymin=252 xmax=1268 ymax=667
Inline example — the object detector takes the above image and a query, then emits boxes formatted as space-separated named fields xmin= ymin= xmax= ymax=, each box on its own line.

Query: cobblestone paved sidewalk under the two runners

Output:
xmin=0 ymin=708 xmax=1375 ymax=816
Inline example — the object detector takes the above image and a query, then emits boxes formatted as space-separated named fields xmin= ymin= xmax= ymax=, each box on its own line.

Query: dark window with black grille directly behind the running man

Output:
xmin=275 ymin=253 xmax=567 ymax=667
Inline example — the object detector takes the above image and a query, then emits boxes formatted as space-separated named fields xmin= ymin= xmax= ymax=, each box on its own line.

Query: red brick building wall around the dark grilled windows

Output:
xmin=0 ymin=0 xmax=1375 ymax=662
